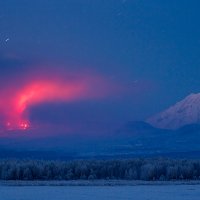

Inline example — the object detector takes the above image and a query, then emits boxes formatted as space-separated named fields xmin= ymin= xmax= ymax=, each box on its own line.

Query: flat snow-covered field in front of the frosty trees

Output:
xmin=0 ymin=185 xmax=200 ymax=200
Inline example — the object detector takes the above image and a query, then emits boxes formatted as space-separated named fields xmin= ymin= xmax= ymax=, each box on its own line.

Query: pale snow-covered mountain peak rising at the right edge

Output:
xmin=147 ymin=93 xmax=200 ymax=130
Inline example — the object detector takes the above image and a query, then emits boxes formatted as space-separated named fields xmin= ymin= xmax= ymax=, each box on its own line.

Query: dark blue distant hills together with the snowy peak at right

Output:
xmin=0 ymin=94 xmax=200 ymax=159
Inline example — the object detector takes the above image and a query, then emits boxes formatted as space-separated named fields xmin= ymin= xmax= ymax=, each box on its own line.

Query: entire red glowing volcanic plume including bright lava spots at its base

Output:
xmin=0 ymin=72 xmax=111 ymax=130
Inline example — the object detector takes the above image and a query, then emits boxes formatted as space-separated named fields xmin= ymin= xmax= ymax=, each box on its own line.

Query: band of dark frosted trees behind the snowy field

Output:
xmin=0 ymin=158 xmax=200 ymax=181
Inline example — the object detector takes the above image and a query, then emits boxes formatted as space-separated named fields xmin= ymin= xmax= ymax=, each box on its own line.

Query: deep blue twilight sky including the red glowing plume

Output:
xmin=0 ymin=0 xmax=200 ymax=136
